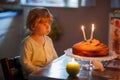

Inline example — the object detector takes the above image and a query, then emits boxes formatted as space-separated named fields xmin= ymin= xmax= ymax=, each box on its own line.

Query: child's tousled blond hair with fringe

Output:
xmin=26 ymin=8 xmax=53 ymax=31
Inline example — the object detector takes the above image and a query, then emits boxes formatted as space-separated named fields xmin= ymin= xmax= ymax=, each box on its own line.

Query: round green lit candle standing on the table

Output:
xmin=66 ymin=58 xmax=80 ymax=76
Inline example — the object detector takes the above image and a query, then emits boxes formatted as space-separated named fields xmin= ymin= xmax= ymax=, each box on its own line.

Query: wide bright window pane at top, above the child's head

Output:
xmin=21 ymin=0 xmax=79 ymax=8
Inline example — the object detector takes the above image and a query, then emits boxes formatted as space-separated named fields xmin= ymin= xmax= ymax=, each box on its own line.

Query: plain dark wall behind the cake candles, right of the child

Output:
xmin=49 ymin=0 xmax=112 ymax=55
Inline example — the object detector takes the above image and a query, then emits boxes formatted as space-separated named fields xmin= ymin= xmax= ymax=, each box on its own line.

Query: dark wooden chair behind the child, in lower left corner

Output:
xmin=0 ymin=56 xmax=24 ymax=80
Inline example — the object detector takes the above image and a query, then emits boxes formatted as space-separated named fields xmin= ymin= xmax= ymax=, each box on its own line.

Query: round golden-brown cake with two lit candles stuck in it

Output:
xmin=72 ymin=39 xmax=109 ymax=57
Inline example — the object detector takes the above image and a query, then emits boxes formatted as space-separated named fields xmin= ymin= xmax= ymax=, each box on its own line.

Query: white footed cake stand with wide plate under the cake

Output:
xmin=64 ymin=48 xmax=117 ymax=70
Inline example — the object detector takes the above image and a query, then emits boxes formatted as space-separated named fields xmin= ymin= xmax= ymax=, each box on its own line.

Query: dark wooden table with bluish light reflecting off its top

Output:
xmin=29 ymin=54 xmax=120 ymax=80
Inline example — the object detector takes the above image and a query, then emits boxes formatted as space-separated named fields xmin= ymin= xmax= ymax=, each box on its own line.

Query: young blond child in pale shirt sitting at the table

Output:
xmin=21 ymin=8 xmax=58 ymax=74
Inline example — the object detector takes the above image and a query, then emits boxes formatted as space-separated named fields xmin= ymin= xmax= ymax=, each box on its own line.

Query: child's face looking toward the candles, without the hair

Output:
xmin=33 ymin=23 xmax=51 ymax=35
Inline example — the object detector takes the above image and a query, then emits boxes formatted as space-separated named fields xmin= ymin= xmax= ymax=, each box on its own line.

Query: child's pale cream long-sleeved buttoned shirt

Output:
xmin=21 ymin=36 xmax=58 ymax=73
